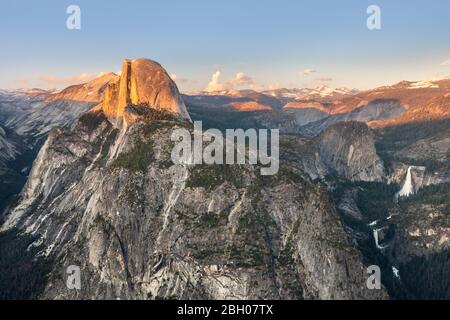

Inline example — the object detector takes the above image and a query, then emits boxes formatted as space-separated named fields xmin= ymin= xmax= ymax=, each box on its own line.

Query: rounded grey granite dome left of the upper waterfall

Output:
xmin=317 ymin=121 xmax=384 ymax=181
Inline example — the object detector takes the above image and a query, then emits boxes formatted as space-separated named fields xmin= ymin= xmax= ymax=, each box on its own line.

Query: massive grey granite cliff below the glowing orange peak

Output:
xmin=1 ymin=59 xmax=386 ymax=299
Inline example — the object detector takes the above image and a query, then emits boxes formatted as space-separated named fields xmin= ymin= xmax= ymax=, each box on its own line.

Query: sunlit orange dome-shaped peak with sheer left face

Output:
xmin=98 ymin=58 xmax=190 ymax=120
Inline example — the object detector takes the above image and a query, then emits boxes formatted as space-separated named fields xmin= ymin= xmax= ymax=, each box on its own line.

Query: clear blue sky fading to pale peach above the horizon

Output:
xmin=0 ymin=0 xmax=450 ymax=91
